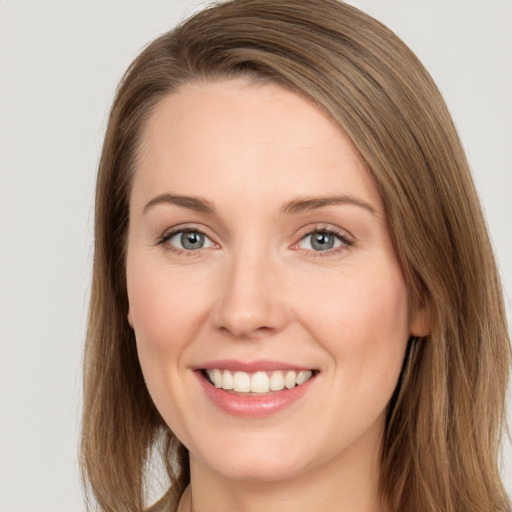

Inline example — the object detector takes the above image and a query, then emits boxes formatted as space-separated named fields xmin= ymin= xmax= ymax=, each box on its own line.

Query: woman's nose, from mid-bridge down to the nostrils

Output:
xmin=213 ymin=249 xmax=289 ymax=339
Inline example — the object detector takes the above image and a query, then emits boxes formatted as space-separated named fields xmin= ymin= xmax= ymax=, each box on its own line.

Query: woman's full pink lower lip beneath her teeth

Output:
xmin=196 ymin=371 xmax=316 ymax=418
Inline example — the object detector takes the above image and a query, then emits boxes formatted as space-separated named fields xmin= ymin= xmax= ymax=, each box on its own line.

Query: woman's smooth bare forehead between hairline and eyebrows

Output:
xmin=134 ymin=79 xmax=380 ymax=212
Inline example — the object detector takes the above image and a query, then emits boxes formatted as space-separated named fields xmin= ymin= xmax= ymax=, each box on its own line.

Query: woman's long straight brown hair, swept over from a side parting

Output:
xmin=81 ymin=0 xmax=510 ymax=512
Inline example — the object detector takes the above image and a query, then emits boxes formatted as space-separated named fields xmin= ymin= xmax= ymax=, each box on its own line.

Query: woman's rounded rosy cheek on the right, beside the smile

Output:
xmin=301 ymin=265 xmax=409 ymax=376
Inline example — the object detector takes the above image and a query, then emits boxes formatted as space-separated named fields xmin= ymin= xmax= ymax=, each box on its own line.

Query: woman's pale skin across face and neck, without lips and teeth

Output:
xmin=127 ymin=79 xmax=428 ymax=512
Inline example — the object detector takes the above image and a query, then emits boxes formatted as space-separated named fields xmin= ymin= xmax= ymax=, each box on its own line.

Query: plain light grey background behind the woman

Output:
xmin=0 ymin=0 xmax=512 ymax=512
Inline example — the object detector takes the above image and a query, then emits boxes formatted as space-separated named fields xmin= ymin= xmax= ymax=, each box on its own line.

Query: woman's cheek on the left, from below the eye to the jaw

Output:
xmin=127 ymin=250 xmax=204 ymax=434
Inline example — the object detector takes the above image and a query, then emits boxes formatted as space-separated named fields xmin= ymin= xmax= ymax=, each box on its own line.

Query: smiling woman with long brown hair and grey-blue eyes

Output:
xmin=82 ymin=0 xmax=510 ymax=512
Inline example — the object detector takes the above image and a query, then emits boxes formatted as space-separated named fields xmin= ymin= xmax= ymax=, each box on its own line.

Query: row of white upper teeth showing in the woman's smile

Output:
xmin=204 ymin=368 xmax=313 ymax=395
